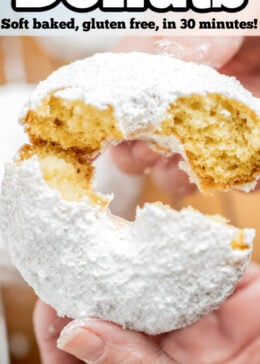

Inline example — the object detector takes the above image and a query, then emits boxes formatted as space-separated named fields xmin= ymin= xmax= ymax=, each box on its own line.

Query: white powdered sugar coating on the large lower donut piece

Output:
xmin=0 ymin=156 xmax=254 ymax=334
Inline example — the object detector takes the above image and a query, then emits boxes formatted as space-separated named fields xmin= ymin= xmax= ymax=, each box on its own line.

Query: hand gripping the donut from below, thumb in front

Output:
xmin=34 ymin=265 xmax=260 ymax=364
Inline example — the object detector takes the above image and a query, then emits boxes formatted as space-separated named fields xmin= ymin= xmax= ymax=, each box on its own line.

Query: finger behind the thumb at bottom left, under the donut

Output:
xmin=33 ymin=301 xmax=77 ymax=364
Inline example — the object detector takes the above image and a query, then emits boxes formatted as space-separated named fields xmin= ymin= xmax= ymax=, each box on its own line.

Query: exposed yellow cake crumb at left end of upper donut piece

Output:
xmin=25 ymin=96 xmax=123 ymax=154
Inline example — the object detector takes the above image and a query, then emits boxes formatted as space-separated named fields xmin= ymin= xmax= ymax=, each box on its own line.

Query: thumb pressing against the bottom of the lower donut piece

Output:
xmin=58 ymin=319 xmax=176 ymax=364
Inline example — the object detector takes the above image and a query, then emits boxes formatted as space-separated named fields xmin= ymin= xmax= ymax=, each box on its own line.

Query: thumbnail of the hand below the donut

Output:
xmin=57 ymin=324 xmax=105 ymax=362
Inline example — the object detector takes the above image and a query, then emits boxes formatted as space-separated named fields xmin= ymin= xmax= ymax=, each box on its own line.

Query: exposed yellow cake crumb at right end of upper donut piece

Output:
xmin=160 ymin=94 xmax=260 ymax=190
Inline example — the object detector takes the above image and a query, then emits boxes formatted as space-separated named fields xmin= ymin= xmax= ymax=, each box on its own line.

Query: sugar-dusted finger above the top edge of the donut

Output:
xmin=115 ymin=36 xmax=243 ymax=68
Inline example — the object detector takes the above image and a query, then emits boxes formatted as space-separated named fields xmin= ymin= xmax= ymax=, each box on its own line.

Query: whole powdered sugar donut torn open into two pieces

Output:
xmin=0 ymin=53 xmax=260 ymax=334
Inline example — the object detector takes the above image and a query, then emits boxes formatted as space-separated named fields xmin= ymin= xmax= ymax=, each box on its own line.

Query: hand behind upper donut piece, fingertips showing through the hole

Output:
xmin=111 ymin=37 xmax=260 ymax=197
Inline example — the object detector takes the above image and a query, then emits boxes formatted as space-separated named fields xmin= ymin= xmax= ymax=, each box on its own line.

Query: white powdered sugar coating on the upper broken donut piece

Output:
xmin=22 ymin=53 xmax=260 ymax=137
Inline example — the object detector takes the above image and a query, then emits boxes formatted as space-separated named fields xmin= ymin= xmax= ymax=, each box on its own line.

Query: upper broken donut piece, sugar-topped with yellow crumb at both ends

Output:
xmin=22 ymin=53 xmax=260 ymax=192
